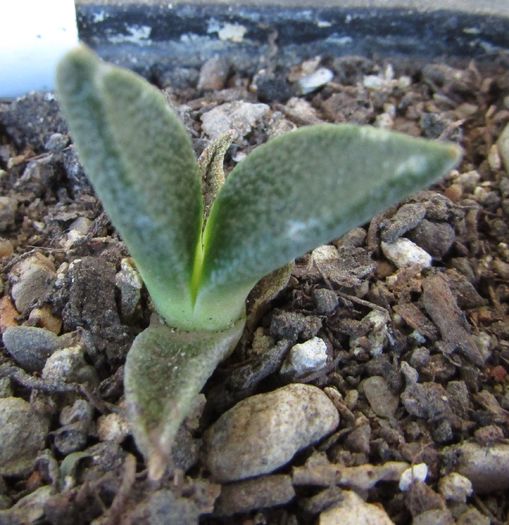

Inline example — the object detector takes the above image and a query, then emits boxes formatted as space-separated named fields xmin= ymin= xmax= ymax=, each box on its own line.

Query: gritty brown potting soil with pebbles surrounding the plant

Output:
xmin=0 ymin=48 xmax=509 ymax=525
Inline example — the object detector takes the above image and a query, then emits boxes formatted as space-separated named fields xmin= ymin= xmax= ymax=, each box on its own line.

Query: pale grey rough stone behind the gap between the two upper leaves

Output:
xmin=201 ymin=101 xmax=270 ymax=140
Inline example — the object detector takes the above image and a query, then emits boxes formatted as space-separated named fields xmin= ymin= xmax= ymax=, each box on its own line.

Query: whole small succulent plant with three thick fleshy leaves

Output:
xmin=57 ymin=47 xmax=459 ymax=476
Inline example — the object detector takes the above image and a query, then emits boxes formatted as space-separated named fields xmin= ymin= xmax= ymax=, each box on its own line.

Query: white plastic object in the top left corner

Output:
xmin=0 ymin=0 xmax=78 ymax=98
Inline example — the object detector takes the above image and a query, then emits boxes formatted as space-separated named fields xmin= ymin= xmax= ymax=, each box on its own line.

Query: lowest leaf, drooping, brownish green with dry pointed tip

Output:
xmin=124 ymin=320 xmax=244 ymax=479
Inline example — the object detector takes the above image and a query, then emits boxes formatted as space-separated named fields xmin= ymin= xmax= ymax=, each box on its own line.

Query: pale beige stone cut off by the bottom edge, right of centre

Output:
xmin=318 ymin=490 xmax=394 ymax=525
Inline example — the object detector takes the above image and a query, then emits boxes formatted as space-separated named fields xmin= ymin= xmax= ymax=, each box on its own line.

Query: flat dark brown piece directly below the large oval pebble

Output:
xmin=214 ymin=474 xmax=295 ymax=516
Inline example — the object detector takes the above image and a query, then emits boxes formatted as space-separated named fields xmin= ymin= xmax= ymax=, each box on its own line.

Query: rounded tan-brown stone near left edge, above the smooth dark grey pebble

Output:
xmin=9 ymin=253 xmax=56 ymax=313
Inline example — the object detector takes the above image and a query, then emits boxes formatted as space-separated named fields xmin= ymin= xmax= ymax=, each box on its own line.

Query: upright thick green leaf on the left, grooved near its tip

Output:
xmin=57 ymin=47 xmax=203 ymax=325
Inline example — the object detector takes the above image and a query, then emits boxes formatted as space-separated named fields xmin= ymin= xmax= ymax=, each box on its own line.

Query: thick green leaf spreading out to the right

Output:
xmin=198 ymin=124 xmax=460 ymax=304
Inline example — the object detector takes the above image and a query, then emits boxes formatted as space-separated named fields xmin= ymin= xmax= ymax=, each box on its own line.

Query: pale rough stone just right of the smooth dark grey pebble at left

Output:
xmin=42 ymin=346 xmax=99 ymax=387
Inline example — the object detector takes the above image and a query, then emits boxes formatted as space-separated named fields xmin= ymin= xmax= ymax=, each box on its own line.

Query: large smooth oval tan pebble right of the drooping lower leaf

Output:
xmin=205 ymin=384 xmax=339 ymax=482
